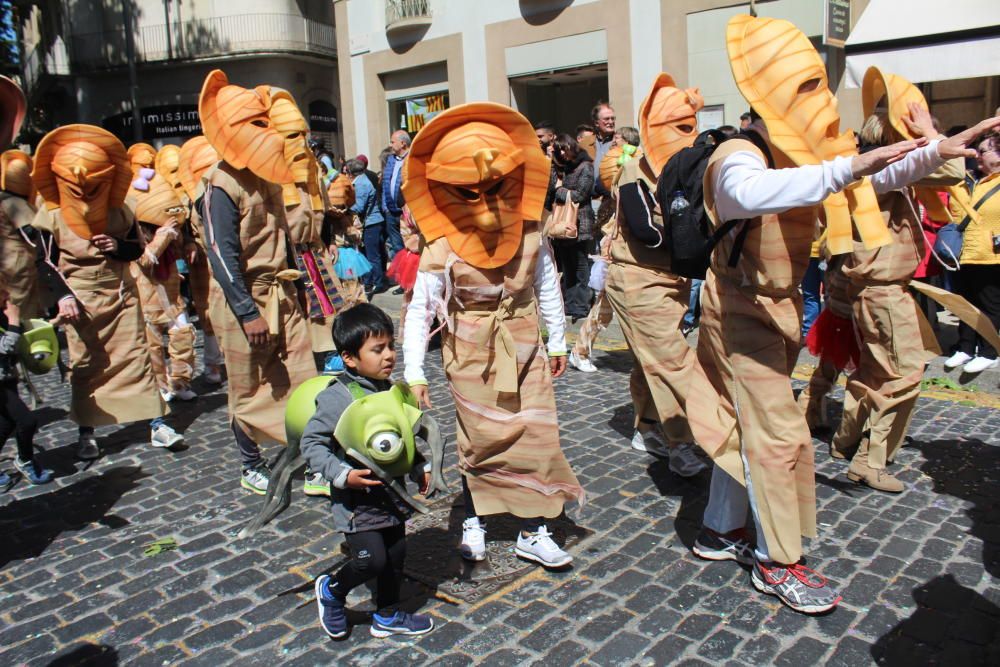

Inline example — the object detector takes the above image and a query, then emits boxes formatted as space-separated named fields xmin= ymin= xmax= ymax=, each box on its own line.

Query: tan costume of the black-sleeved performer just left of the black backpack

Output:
xmin=604 ymin=158 xmax=695 ymax=443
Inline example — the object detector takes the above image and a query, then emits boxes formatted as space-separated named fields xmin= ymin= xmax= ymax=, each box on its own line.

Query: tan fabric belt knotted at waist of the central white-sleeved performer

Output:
xmin=456 ymin=289 xmax=535 ymax=393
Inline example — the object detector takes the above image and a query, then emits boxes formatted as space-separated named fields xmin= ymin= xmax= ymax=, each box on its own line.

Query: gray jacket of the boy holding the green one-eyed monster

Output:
xmin=299 ymin=371 xmax=426 ymax=533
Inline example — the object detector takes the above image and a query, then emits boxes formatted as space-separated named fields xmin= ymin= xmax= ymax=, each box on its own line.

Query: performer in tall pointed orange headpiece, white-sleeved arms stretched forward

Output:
xmin=688 ymin=15 xmax=988 ymax=614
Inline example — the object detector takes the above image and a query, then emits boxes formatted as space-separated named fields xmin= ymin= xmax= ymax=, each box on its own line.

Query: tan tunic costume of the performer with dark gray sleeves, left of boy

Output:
xmin=205 ymin=162 xmax=316 ymax=444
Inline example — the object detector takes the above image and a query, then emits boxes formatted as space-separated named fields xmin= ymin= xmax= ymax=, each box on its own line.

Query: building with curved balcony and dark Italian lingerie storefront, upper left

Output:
xmin=18 ymin=0 xmax=342 ymax=150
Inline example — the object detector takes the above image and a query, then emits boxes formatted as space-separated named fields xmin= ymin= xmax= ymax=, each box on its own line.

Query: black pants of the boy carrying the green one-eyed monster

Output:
xmin=333 ymin=526 xmax=406 ymax=616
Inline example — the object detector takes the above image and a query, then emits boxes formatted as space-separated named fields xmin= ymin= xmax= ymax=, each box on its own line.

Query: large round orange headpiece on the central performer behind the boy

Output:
xmin=403 ymin=102 xmax=550 ymax=269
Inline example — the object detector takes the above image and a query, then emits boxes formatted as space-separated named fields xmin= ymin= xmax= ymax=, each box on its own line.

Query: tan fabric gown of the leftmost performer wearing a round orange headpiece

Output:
xmin=33 ymin=208 xmax=167 ymax=427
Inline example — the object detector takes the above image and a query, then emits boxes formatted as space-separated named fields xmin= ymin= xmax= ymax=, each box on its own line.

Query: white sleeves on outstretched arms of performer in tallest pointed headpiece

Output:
xmin=712 ymin=140 xmax=945 ymax=222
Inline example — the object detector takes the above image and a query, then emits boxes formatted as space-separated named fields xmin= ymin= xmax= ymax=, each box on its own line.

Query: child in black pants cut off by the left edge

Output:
xmin=0 ymin=278 xmax=52 ymax=488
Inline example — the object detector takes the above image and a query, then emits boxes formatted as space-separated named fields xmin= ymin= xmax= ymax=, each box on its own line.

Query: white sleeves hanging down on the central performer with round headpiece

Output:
xmin=403 ymin=239 xmax=566 ymax=384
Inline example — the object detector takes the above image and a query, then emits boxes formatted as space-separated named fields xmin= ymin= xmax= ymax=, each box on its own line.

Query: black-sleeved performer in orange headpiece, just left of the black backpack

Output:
xmin=604 ymin=73 xmax=707 ymax=477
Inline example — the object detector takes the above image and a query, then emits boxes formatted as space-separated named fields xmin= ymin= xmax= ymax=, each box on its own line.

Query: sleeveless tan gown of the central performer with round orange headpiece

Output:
xmin=420 ymin=222 xmax=583 ymax=518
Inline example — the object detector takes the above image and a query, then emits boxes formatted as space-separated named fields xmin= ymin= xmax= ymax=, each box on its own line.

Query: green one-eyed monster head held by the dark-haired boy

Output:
xmin=333 ymin=384 xmax=421 ymax=477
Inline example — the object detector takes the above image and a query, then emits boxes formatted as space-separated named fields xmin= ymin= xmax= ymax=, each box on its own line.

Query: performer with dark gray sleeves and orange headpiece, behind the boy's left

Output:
xmin=198 ymin=70 xmax=316 ymax=495
